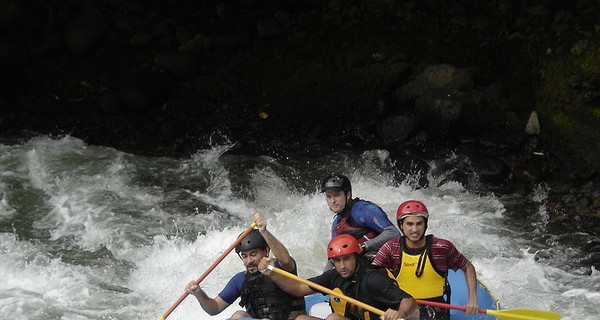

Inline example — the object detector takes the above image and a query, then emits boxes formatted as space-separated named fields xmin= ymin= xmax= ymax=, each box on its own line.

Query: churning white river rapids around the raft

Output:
xmin=0 ymin=136 xmax=600 ymax=320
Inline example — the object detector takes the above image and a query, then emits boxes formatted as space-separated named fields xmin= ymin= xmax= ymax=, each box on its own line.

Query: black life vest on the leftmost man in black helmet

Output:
xmin=240 ymin=272 xmax=305 ymax=320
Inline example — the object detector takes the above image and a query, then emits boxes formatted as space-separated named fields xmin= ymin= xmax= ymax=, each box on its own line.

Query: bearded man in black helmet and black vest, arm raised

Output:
xmin=185 ymin=213 xmax=305 ymax=320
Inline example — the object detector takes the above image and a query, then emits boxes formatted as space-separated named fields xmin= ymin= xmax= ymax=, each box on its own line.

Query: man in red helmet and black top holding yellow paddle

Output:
xmin=259 ymin=234 xmax=418 ymax=320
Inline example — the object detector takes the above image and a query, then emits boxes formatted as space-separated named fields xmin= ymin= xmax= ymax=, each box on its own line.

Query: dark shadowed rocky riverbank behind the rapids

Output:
xmin=0 ymin=0 xmax=600 ymax=234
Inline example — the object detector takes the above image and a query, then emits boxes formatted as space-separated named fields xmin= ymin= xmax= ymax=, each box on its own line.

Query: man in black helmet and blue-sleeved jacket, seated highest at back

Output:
xmin=321 ymin=174 xmax=400 ymax=268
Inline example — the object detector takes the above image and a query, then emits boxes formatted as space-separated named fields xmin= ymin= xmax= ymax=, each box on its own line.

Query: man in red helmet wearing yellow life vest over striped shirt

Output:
xmin=373 ymin=200 xmax=479 ymax=320
